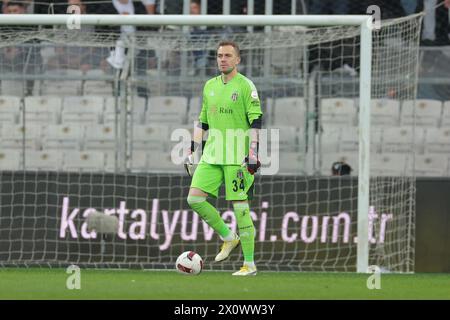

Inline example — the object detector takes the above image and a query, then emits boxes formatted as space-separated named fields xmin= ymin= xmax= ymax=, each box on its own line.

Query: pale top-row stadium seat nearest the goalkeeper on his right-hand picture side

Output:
xmin=273 ymin=97 xmax=307 ymax=128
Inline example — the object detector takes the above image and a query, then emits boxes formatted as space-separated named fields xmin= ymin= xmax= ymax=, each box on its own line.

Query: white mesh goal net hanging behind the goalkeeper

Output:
xmin=0 ymin=15 xmax=421 ymax=272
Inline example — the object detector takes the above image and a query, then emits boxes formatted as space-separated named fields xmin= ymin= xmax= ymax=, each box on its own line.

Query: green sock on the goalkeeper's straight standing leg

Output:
xmin=233 ymin=202 xmax=255 ymax=263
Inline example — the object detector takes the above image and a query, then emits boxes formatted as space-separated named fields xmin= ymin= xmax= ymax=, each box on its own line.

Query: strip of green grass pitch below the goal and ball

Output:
xmin=0 ymin=269 xmax=450 ymax=300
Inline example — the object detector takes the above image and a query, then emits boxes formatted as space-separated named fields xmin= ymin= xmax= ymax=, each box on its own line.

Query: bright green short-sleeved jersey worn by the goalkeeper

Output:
xmin=199 ymin=73 xmax=262 ymax=165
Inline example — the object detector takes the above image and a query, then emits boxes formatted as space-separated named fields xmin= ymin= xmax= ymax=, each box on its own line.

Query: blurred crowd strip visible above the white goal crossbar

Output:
xmin=1 ymin=0 xmax=450 ymax=46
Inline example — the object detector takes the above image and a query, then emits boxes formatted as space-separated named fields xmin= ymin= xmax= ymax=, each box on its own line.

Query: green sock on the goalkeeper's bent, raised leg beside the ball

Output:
xmin=187 ymin=196 xmax=231 ymax=238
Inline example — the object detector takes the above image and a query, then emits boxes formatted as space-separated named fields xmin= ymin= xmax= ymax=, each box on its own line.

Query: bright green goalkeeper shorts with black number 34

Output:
xmin=191 ymin=161 xmax=255 ymax=201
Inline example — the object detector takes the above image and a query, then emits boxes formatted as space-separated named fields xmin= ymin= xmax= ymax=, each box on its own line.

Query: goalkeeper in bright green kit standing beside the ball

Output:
xmin=186 ymin=41 xmax=262 ymax=276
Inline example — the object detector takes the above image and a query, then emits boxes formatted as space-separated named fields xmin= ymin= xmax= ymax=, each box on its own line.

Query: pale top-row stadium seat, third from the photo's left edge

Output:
xmin=61 ymin=96 xmax=104 ymax=124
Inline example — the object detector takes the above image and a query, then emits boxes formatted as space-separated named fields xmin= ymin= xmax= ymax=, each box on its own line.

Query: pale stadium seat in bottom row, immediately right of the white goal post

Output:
xmin=370 ymin=153 xmax=413 ymax=176
